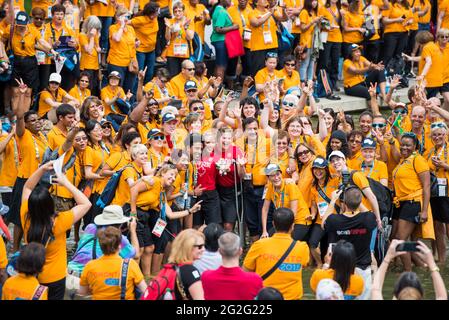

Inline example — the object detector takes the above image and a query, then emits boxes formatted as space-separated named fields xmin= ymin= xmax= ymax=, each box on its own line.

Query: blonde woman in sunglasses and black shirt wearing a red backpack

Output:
xmin=168 ymin=229 xmax=205 ymax=300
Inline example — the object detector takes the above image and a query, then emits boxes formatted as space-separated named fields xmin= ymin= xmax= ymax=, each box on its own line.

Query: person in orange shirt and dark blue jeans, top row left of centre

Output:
xmin=128 ymin=2 xmax=159 ymax=83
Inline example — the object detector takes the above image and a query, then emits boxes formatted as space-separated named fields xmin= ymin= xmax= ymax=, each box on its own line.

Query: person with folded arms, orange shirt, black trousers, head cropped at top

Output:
xmin=382 ymin=0 xmax=413 ymax=65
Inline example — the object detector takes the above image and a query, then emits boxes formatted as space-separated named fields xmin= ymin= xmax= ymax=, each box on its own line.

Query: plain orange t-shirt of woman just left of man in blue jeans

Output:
xmin=108 ymin=24 xmax=136 ymax=67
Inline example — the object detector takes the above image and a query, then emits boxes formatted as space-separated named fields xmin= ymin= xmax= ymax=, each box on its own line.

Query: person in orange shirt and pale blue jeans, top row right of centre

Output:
xmin=299 ymin=0 xmax=323 ymax=82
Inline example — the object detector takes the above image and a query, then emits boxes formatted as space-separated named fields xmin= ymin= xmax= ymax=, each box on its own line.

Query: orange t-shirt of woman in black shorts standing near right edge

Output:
xmin=393 ymin=154 xmax=429 ymax=199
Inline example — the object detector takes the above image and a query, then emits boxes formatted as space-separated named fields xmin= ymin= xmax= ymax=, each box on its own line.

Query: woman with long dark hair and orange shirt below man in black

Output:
xmin=310 ymin=240 xmax=363 ymax=300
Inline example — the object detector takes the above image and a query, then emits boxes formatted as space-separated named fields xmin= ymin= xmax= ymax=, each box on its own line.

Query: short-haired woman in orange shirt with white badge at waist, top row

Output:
xmin=165 ymin=1 xmax=195 ymax=77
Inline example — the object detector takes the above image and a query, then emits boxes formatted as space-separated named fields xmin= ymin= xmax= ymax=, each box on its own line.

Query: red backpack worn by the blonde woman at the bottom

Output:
xmin=141 ymin=263 xmax=187 ymax=300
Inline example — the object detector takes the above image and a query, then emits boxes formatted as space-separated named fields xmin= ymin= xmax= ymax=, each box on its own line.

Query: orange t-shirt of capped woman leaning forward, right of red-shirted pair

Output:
xmin=265 ymin=181 xmax=310 ymax=225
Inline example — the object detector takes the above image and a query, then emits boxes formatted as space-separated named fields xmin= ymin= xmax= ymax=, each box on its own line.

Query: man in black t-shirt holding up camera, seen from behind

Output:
xmin=321 ymin=185 xmax=376 ymax=300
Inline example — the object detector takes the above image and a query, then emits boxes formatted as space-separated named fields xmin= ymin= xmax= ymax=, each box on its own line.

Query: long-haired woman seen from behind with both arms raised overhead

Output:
xmin=20 ymin=162 xmax=91 ymax=300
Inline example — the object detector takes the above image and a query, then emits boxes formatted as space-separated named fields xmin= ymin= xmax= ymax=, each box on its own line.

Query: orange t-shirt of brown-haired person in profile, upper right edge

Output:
xmin=418 ymin=41 xmax=444 ymax=88
